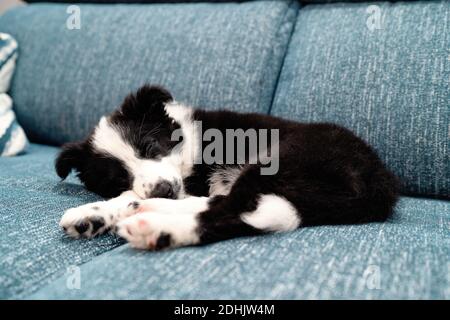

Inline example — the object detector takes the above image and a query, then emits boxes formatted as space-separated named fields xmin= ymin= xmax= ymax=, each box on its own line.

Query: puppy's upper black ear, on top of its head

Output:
xmin=121 ymin=85 xmax=173 ymax=117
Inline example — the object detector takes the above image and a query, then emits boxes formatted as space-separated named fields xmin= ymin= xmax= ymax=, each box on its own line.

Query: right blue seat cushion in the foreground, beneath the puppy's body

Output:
xmin=31 ymin=198 xmax=450 ymax=299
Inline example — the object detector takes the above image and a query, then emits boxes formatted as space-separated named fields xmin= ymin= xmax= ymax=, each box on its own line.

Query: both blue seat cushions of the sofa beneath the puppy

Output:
xmin=0 ymin=145 xmax=450 ymax=299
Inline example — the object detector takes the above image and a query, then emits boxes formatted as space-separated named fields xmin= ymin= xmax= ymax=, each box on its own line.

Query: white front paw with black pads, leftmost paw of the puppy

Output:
xmin=59 ymin=204 xmax=110 ymax=238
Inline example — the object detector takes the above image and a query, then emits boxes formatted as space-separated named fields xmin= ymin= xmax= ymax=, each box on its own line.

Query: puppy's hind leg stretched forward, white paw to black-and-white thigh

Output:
xmin=117 ymin=168 xmax=301 ymax=249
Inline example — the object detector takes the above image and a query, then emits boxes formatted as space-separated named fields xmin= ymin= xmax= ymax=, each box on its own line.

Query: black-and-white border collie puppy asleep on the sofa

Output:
xmin=56 ymin=85 xmax=397 ymax=250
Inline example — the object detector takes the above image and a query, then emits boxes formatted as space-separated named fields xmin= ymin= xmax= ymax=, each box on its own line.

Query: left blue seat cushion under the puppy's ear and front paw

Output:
xmin=0 ymin=145 xmax=121 ymax=299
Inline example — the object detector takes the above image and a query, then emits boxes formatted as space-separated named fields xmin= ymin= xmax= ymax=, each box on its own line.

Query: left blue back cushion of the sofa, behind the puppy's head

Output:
xmin=0 ymin=1 xmax=298 ymax=143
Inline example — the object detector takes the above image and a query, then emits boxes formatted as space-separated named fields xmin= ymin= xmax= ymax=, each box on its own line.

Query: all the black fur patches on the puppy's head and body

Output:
xmin=56 ymin=86 xmax=398 ymax=247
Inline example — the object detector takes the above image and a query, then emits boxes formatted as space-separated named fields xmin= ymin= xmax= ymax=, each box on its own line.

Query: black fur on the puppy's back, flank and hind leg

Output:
xmin=181 ymin=110 xmax=398 ymax=243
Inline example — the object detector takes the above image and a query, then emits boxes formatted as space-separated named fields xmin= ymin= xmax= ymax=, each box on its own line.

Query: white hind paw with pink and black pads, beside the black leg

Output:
xmin=116 ymin=212 xmax=199 ymax=250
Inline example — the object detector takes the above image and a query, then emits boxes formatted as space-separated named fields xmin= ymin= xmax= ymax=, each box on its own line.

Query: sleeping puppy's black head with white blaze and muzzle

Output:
xmin=55 ymin=86 xmax=186 ymax=198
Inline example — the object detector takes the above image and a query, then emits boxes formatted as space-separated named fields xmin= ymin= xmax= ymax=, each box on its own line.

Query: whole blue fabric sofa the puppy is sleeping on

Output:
xmin=0 ymin=0 xmax=450 ymax=299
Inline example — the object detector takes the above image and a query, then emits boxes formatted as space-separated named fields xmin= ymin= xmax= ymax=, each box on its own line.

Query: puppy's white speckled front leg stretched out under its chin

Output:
xmin=59 ymin=191 xmax=140 ymax=238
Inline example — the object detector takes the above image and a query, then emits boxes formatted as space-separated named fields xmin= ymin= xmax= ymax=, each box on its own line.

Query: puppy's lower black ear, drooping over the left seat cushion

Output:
xmin=55 ymin=142 xmax=86 ymax=180
